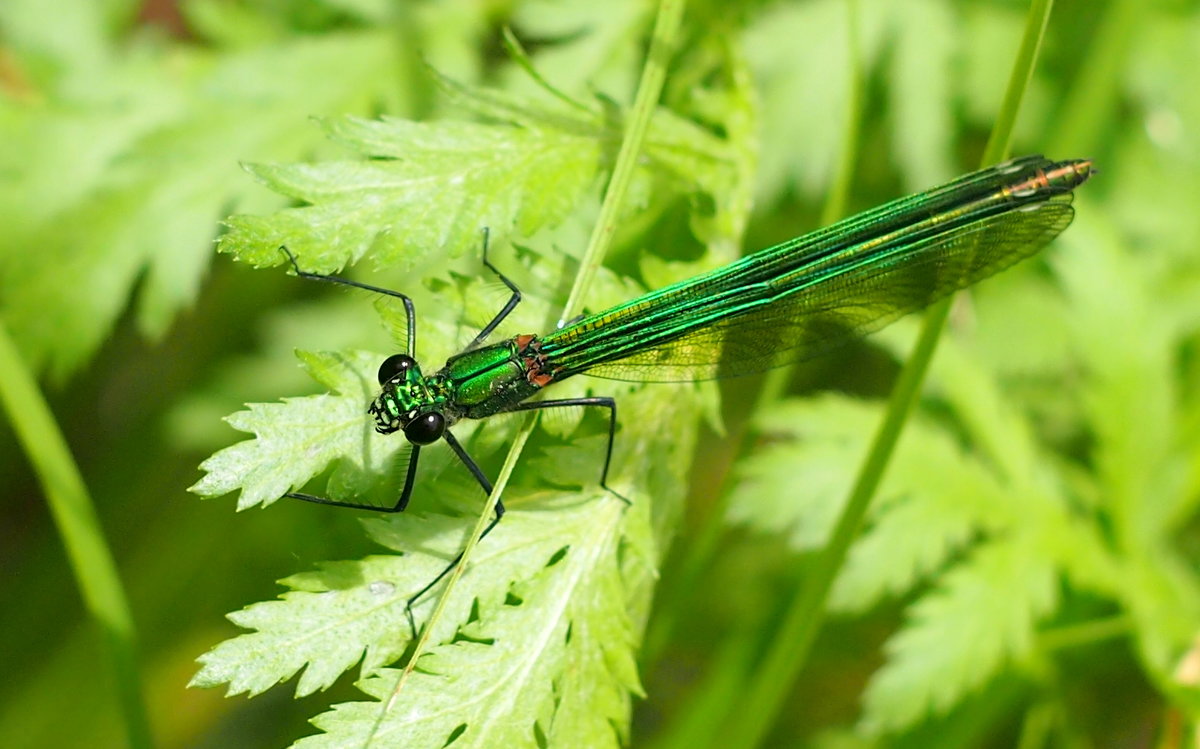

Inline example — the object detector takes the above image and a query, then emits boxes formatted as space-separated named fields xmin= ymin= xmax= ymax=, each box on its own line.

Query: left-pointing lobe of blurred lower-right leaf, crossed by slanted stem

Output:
xmin=730 ymin=396 xmax=1025 ymax=611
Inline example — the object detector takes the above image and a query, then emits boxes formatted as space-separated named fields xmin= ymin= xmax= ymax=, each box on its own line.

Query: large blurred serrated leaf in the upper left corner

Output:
xmin=0 ymin=32 xmax=403 ymax=379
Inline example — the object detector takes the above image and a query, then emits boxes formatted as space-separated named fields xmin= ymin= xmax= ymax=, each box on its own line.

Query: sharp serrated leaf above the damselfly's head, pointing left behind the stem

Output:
xmin=220 ymin=73 xmax=731 ymax=272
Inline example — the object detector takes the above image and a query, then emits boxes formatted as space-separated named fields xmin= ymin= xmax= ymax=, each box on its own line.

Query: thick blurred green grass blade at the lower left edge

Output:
xmin=0 ymin=322 xmax=152 ymax=749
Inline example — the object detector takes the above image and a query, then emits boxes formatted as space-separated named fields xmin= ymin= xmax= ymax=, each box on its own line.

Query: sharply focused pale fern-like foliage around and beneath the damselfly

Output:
xmin=192 ymin=63 xmax=728 ymax=747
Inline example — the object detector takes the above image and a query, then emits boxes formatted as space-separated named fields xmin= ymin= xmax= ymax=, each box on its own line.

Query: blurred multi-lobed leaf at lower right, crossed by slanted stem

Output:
xmin=731 ymin=335 xmax=1123 ymax=733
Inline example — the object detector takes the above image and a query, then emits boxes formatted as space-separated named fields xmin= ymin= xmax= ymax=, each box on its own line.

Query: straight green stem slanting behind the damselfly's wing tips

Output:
xmin=725 ymin=0 xmax=1052 ymax=748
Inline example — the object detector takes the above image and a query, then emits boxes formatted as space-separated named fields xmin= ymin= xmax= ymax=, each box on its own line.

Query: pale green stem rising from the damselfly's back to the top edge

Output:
xmin=558 ymin=0 xmax=684 ymax=326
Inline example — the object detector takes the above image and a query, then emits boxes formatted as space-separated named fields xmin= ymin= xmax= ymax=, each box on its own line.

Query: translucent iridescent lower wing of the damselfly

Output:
xmin=551 ymin=193 xmax=1074 ymax=382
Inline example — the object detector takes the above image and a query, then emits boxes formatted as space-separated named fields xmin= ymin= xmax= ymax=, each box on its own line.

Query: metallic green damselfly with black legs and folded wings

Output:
xmin=284 ymin=156 xmax=1092 ymax=532
